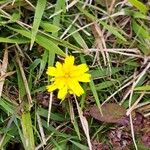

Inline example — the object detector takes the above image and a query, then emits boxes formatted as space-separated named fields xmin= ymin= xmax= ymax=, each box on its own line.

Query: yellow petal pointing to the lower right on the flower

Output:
xmin=68 ymin=79 xmax=84 ymax=96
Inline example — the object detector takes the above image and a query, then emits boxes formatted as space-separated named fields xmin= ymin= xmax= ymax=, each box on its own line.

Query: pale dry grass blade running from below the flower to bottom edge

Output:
xmin=74 ymin=96 xmax=92 ymax=150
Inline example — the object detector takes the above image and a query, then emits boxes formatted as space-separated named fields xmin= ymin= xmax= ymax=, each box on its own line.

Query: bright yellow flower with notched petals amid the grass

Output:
xmin=46 ymin=56 xmax=91 ymax=100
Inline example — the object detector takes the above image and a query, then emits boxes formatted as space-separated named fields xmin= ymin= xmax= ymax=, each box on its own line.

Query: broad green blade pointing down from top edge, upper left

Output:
xmin=30 ymin=0 xmax=46 ymax=49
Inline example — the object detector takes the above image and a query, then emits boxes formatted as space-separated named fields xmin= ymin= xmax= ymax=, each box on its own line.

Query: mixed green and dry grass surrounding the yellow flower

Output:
xmin=0 ymin=0 xmax=150 ymax=150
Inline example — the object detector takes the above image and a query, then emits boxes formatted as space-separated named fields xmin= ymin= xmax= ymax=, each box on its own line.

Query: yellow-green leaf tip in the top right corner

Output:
xmin=128 ymin=0 xmax=148 ymax=13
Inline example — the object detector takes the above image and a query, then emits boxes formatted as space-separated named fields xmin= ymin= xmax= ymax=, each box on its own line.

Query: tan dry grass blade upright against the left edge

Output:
xmin=0 ymin=48 xmax=8 ymax=97
